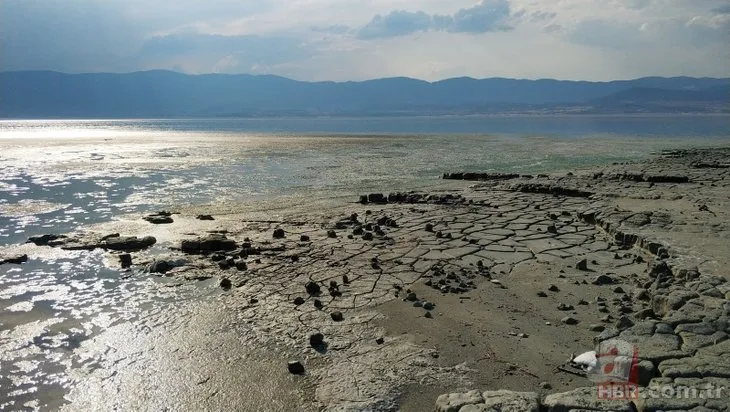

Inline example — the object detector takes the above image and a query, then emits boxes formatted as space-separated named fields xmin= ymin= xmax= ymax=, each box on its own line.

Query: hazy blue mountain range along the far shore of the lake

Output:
xmin=0 ymin=71 xmax=730 ymax=118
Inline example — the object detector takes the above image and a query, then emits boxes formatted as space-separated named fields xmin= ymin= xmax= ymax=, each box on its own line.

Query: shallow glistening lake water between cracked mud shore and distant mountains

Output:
xmin=0 ymin=116 xmax=730 ymax=409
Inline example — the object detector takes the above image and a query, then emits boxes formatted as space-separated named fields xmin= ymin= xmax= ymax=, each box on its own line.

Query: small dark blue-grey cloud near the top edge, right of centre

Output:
xmin=357 ymin=0 xmax=511 ymax=40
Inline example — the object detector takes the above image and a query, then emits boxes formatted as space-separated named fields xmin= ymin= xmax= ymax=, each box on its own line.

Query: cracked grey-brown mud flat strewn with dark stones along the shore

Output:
xmin=2 ymin=148 xmax=730 ymax=411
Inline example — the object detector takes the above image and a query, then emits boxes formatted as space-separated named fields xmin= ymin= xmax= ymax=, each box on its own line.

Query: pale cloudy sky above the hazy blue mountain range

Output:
xmin=0 ymin=0 xmax=730 ymax=81
